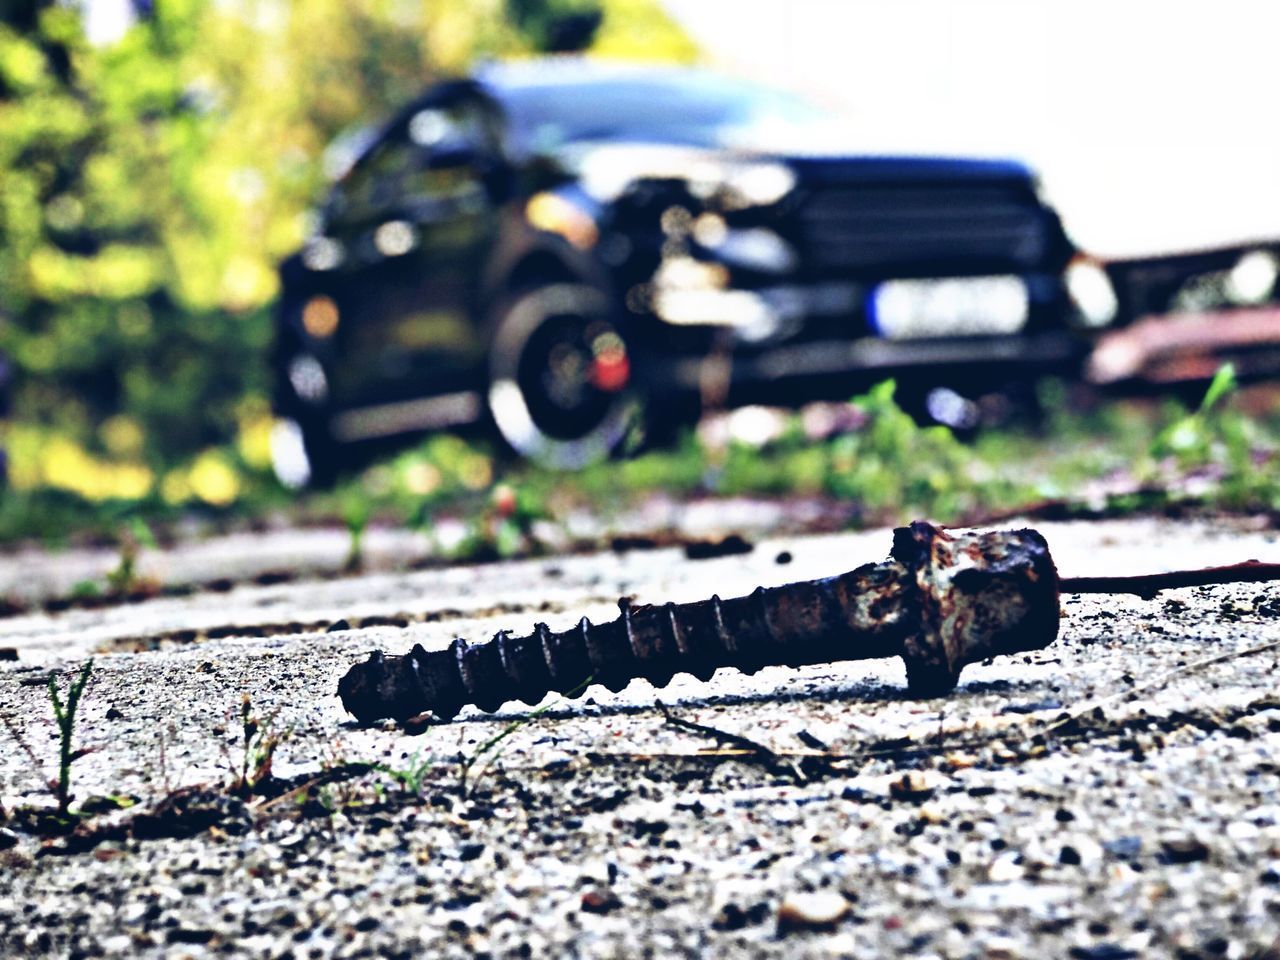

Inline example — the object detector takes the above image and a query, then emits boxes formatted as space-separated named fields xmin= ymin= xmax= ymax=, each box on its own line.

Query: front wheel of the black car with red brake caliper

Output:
xmin=486 ymin=283 xmax=640 ymax=470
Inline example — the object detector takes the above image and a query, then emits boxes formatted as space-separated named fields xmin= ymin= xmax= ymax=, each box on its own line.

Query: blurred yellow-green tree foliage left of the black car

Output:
xmin=0 ymin=0 xmax=690 ymax=504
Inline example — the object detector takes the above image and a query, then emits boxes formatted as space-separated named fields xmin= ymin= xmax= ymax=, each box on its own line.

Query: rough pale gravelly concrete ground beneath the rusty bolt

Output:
xmin=0 ymin=520 xmax=1280 ymax=960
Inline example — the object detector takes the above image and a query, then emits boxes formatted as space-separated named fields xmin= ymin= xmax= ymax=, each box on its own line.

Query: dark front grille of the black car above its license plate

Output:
xmin=797 ymin=184 xmax=1050 ymax=273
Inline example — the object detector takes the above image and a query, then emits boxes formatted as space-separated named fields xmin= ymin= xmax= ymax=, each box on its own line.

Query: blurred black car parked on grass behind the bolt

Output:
xmin=275 ymin=59 xmax=1079 ymax=479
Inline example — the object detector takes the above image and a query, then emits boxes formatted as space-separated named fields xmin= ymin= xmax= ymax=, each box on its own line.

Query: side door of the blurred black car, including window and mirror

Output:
xmin=329 ymin=87 xmax=500 ymax=417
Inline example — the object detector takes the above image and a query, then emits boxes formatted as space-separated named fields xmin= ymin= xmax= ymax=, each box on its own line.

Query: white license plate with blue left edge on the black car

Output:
xmin=868 ymin=276 xmax=1030 ymax=340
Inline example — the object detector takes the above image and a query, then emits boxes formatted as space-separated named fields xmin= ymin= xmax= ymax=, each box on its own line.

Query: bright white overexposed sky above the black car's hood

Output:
xmin=663 ymin=0 xmax=1280 ymax=255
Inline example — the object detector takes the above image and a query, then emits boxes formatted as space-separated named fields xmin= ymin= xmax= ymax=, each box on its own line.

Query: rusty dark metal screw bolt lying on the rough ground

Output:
xmin=338 ymin=521 xmax=1059 ymax=721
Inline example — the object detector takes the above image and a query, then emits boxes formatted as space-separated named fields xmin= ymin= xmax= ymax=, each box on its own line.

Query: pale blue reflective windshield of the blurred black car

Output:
xmin=488 ymin=70 xmax=826 ymax=152
